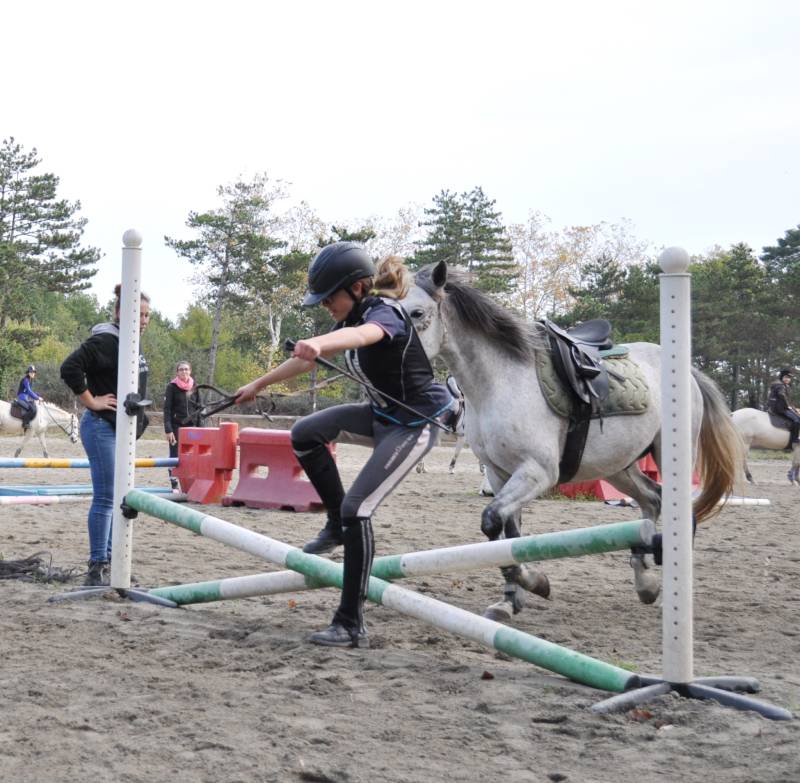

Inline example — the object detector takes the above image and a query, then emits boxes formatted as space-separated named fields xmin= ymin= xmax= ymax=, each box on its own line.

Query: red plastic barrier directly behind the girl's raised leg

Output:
xmin=222 ymin=427 xmax=336 ymax=511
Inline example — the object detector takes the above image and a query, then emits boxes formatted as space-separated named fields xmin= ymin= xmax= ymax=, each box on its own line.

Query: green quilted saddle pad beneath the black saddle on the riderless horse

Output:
xmin=536 ymin=345 xmax=650 ymax=419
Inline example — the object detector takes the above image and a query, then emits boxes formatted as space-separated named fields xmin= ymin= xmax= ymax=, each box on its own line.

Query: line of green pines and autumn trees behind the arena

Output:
xmin=0 ymin=138 xmax=800 ymax=412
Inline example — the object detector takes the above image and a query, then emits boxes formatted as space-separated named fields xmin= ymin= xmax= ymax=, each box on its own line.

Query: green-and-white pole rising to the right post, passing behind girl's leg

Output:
xmin=149 ymin=519 xmax=655 ymax=605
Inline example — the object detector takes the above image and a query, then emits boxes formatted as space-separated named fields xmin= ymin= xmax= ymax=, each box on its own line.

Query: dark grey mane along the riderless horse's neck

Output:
xmin=444 ymin=269 xmax=542 ymax=362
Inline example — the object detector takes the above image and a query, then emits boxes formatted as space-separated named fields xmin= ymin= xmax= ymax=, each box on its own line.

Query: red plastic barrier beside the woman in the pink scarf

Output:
xmin=172 ymin=422 xmax=239 ymax=503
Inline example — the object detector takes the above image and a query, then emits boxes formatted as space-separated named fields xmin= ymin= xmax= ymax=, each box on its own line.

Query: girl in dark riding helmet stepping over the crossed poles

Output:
xmin=237 ymin=242 xmax=453 ymax=647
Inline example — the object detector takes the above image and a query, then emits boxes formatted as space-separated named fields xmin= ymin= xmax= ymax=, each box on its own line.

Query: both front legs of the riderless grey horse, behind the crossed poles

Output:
xmin=481 ymin=465 xmax=550 ymax=622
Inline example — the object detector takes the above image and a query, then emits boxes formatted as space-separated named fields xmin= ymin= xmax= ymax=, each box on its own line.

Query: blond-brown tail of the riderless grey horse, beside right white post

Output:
xmin=692 ymin=369 xmax=745 ymax=523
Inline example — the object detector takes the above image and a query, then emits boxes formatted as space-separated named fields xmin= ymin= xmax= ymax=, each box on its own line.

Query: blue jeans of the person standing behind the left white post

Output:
xmin=81 ymin=410 xmax=116 ymax=560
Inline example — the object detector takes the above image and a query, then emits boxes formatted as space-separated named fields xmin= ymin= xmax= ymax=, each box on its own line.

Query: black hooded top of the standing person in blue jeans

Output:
xmin=61 ymin=324 xmax=148 ymax=427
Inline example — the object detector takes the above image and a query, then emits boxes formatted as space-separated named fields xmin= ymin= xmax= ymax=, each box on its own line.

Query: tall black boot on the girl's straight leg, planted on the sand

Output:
xmin=309 ymin=517 xmax=375 ymax=647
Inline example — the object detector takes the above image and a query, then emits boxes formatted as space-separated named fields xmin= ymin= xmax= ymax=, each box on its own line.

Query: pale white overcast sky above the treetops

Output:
xmin=0 ymin=0 xmax=800 ymax=318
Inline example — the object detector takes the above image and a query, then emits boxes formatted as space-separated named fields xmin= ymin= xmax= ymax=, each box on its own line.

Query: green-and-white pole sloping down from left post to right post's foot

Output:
xmin=130 ymin=489 xmax=640 ymax=692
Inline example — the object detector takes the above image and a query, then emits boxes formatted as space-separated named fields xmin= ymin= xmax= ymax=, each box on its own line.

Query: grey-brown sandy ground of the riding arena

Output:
xmin=0 ymin=438 xmax=800 ymax=783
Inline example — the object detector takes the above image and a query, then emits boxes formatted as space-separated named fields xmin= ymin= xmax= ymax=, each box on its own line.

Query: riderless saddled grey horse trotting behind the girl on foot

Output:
xmin=402 ymin=262 xmax=743 ymax=622
